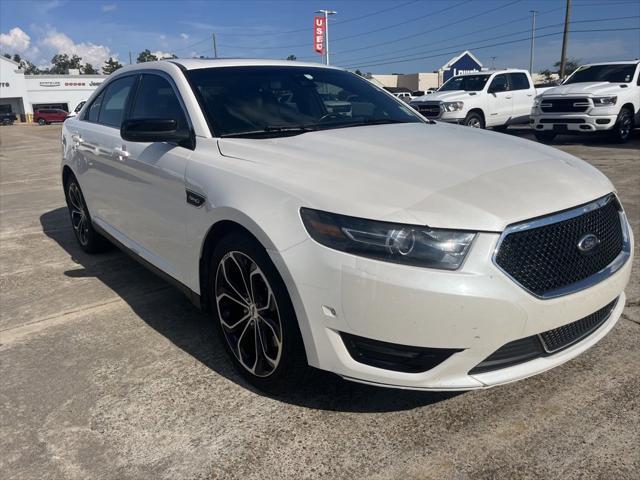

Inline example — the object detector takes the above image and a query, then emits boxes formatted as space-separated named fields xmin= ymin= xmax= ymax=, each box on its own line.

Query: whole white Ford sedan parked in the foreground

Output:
xmin=62 ymin=60 xmax=633 ymax=390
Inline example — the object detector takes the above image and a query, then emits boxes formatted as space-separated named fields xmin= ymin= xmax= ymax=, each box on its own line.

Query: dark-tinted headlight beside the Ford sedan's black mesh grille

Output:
xmin=300 ymin=208 xmax=476 ymax=270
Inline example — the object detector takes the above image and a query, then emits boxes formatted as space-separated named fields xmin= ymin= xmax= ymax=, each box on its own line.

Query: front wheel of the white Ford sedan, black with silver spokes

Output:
xmin=207 ymin=233 xmax=309 ymax=393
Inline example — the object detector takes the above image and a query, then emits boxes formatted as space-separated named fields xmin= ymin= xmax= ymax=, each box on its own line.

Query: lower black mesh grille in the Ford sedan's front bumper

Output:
xmin=469 ymin=298 xmax=618 ymax=375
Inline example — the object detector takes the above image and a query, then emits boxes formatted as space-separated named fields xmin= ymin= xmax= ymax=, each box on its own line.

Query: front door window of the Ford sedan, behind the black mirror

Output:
xmin=131 ymin=75 xmax=187 ymax=128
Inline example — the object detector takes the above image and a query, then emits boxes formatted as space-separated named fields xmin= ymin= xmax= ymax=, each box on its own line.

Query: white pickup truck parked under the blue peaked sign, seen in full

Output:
xmin=411 ymin=68 xmax=545 ymax=129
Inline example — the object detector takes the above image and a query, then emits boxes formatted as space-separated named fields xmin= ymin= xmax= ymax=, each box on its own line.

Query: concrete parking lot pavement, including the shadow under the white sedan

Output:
xmin=0 ymin=125 xmax=640 ymax=479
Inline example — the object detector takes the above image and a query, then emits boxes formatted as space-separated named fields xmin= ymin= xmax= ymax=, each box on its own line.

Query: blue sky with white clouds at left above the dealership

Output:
xmin=0 ymin=0 xmax=640 ymax=73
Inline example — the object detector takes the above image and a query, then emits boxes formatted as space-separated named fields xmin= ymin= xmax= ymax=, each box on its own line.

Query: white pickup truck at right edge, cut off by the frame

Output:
xmin=531 ymin=60 xmax=640 ymax=143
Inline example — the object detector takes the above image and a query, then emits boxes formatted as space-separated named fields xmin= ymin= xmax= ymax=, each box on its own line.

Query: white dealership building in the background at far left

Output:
xmin=0 ymin=56 xmax=107 ymax=122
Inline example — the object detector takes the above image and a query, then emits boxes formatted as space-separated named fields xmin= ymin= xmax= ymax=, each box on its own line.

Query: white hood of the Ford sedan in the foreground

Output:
xmin=218 ymin=123 xmax=613 ymax=231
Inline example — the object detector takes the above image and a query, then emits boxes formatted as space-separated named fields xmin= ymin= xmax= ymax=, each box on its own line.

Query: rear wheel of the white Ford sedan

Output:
xmin=64 ymin=177 xmax=110 ymax=253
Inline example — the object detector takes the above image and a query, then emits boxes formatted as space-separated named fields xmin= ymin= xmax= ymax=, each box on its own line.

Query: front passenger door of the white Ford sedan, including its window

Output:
xmin=109 ymin=71 xmax=194 ymax=280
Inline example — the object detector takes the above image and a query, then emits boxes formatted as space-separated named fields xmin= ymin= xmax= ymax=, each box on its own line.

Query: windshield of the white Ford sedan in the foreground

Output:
xmin=186 ymin=66 xmax=424 ymax=138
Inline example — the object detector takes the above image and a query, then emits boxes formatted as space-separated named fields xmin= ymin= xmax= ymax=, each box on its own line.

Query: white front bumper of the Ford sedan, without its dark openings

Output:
xmin=272 ymin=218 xmax=633 ymax=390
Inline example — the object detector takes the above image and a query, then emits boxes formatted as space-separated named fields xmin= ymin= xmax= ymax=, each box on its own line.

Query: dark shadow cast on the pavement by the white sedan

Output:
xmin=40 ymin=208 xmax=460 ymax=412
